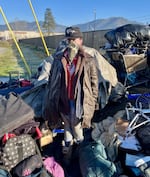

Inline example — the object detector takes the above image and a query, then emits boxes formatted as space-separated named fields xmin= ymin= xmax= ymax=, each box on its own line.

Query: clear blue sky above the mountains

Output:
xmin=0 ymin=0 xmax=150 ymax=26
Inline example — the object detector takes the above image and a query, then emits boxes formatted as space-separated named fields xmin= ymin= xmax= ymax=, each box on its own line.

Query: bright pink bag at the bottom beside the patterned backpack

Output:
xmin=44 ymin=157 xmax=65 ymax=177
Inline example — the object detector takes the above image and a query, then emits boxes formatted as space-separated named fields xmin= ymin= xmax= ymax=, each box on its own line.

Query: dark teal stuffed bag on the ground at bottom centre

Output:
xmin=79 ymin=141 xmax=118 ymax=177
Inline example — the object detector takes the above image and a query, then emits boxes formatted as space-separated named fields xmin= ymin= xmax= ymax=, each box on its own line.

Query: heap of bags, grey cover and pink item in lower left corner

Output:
xmin=0 ymin=92 xmax=64 ymax=177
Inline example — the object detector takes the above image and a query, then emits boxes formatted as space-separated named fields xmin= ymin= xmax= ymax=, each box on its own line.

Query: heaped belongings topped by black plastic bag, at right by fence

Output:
xmin=100 ymin=24 xmax=150 ymax=86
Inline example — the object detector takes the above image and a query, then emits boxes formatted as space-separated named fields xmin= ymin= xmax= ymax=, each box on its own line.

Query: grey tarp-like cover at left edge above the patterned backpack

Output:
xmin=0 ymin=92 xmax=34 ymax=137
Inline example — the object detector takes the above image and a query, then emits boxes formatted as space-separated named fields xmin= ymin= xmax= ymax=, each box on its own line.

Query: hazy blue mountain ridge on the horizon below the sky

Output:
xmin=0 ymin=17 xmax=140 ymax=32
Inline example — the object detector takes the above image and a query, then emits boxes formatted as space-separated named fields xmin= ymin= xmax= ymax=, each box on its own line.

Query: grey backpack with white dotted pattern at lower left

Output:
xmin=1 ymin=134 xmax=37 ymax=171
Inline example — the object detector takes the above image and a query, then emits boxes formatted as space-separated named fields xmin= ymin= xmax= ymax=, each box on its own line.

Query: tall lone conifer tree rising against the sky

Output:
xmin=43 ymin=8 xmax=55 ymax=35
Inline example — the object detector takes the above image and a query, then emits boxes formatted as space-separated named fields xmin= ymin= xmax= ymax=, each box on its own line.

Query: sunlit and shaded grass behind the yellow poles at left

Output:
xmin=0 ymin=41 xmax=54 ymax=77
